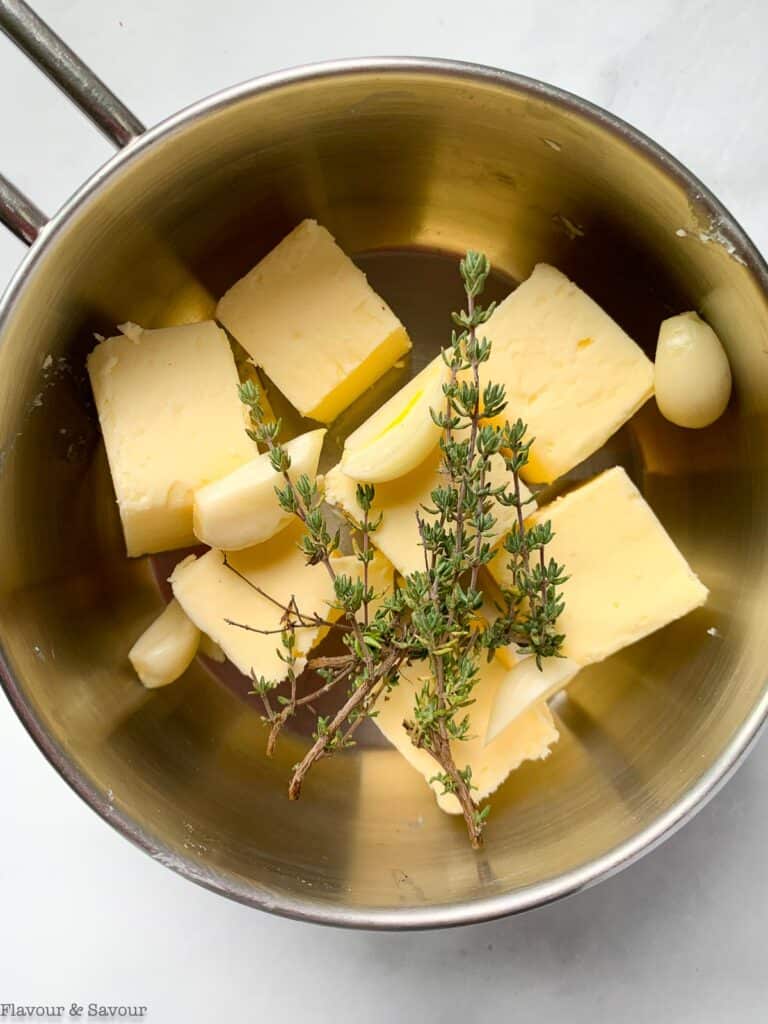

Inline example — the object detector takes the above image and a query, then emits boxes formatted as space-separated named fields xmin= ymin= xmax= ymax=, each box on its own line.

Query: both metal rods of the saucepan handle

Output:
xmin=0 ymin=0 xmax=144 ymax=245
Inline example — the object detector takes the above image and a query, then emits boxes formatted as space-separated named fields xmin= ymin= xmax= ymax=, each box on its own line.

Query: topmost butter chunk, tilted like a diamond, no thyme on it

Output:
xmin=216 ymin=220 xmax=411 ymax=423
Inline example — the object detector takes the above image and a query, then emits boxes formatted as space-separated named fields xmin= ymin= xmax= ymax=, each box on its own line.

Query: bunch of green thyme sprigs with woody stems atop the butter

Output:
xmin=225 ymin=252 xmax=566 ymax=847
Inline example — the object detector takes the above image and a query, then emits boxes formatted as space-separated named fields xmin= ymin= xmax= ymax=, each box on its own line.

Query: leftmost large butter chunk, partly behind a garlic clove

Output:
xmin=88 ymin=321 xmax=258 ymax=556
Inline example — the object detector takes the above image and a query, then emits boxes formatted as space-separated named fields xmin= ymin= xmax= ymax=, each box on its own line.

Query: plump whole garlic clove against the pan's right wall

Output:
xmin=655 ymin=312 xmax=732 ymax=428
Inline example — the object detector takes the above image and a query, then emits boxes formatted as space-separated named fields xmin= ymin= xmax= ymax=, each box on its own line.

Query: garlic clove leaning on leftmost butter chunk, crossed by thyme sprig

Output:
xmin=193 ymin=429 xmax=326 ymax=551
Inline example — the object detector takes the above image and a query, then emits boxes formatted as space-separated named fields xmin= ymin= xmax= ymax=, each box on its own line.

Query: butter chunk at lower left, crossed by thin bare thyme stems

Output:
xmin=170 ymin=521 xmax=336 ymax=681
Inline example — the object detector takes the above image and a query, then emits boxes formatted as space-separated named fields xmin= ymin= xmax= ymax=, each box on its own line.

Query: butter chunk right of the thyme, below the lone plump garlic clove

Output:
xmin=489 ymin=467 xmax=708 ymax=665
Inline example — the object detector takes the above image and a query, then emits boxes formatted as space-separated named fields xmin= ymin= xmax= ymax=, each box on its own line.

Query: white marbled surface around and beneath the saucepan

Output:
xmin=0 ymin=0 xmax=768 ymax=1024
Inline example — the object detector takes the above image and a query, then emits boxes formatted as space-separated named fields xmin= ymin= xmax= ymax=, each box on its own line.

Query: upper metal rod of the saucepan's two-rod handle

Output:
xmin=0 ymin=0 xmax=144 ymax=145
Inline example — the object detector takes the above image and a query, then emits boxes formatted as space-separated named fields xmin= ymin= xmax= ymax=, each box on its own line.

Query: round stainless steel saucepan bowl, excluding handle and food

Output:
xmin=0 ymin=59 xmax=768 ymax=928
